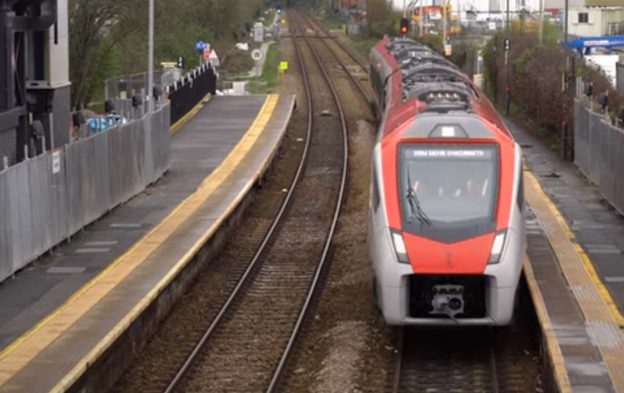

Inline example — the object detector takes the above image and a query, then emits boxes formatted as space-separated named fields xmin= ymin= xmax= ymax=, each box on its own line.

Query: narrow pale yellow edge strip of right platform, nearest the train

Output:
xmin=523 ymin=256 xmax=572 ymax=393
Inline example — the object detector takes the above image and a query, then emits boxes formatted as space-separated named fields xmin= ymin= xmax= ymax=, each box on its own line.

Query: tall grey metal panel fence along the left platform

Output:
xmin=0 ymin=105 xmax=171 ymax=281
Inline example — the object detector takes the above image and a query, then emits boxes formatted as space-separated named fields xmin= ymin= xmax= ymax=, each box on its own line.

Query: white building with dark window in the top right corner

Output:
xmin=568 ymin=7 xmax=624 ymax=37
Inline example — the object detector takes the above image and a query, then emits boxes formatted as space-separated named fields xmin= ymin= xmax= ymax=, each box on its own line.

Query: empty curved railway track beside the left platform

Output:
xmin=113 ymin=8 xmax=348 ymax=392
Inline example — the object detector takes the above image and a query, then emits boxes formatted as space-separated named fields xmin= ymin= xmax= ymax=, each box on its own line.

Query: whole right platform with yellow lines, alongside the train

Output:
xmin=506 ymin=120 xmax=624 ymax=392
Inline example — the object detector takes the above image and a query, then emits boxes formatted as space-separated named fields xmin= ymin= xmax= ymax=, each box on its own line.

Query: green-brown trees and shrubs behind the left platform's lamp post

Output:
xmin=68 ymin=0 xmax=267 ymax=108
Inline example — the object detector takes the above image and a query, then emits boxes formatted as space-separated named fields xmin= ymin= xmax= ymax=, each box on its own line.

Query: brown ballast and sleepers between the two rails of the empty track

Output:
xmin=173 ymin=29 xmax=346 ymax=392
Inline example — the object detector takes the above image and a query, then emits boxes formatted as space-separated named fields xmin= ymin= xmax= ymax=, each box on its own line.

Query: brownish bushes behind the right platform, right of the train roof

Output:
xmin=484 ymin=24 xmax=621 ymax=139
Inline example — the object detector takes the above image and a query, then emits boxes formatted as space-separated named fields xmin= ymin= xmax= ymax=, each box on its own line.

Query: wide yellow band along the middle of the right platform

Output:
xmin=525 ymin=171 xmax=624 ymax=392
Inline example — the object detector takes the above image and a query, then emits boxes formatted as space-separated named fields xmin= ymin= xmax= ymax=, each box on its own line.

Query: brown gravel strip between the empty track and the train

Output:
xmin=280 ymin=26 xmax=394 ymax=393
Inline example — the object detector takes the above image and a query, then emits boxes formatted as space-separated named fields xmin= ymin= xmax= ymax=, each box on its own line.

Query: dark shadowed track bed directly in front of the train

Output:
xmin=392 ymin=285 xmax=544 ymax=393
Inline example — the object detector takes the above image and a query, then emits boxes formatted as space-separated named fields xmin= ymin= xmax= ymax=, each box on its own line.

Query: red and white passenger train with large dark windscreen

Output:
xmin=368 ymin=38 xmax=526 ymax=325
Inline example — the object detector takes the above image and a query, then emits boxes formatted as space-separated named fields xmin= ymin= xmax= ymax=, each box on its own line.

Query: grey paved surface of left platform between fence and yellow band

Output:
xmin=0 ymin=97 xmax=264 ymax=351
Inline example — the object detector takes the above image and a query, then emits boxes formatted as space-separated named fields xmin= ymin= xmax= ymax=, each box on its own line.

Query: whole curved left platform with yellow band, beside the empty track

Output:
xmin=0 ymin=95 xmax=294 ymax=392
